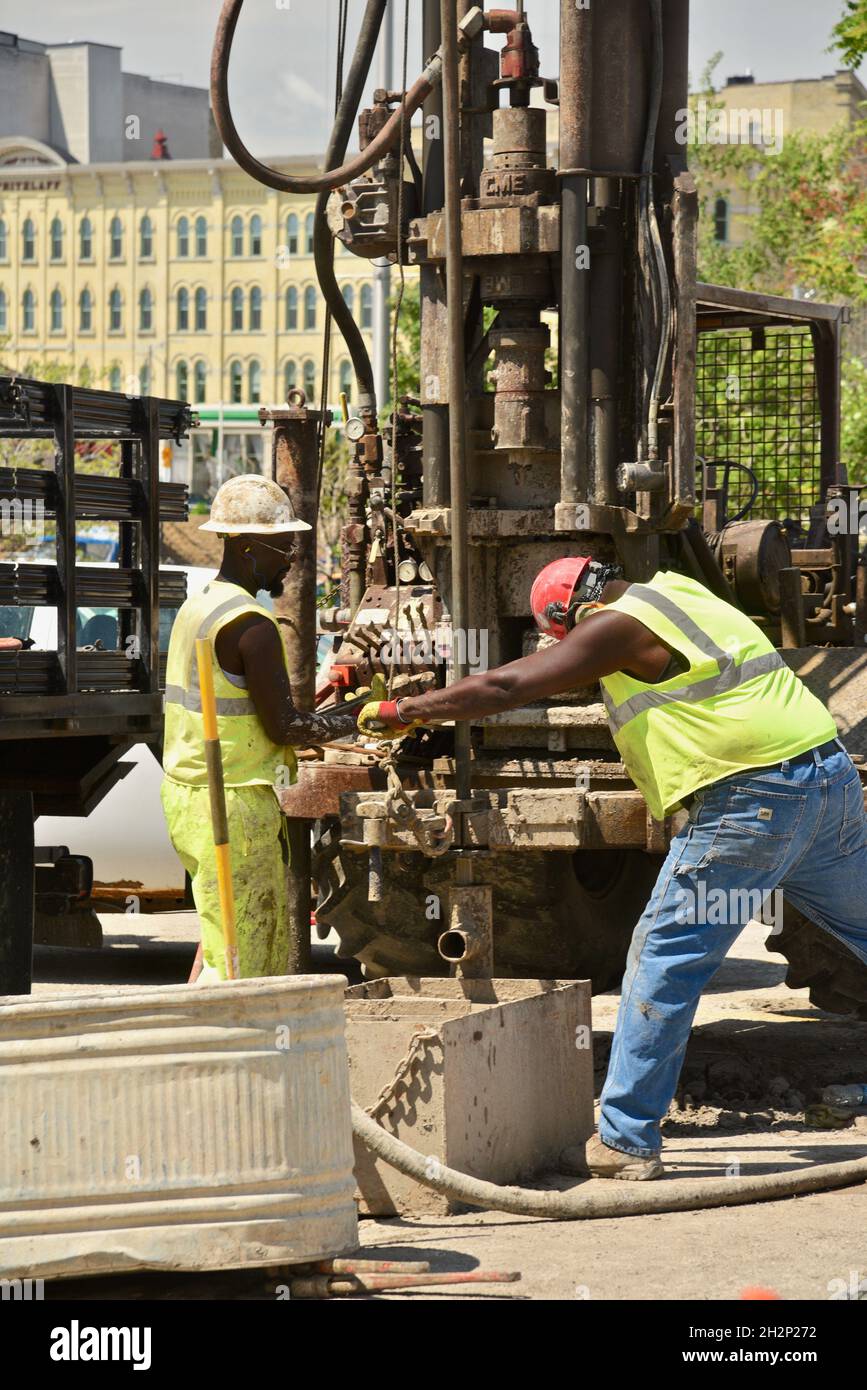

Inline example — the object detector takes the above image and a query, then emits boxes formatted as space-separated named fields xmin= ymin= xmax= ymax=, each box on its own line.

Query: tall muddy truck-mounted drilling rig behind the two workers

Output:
xmin=214 ymin=0 xmax=867 ymax=1016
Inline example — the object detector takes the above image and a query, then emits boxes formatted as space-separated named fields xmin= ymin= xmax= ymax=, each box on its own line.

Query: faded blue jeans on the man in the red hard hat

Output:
xmin=599 ymin=745 xmax=867 ymax=1156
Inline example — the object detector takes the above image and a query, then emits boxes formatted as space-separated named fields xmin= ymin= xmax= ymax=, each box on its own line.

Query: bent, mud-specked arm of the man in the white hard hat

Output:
xmin=215 ymin=613 xmax=358 ymax=745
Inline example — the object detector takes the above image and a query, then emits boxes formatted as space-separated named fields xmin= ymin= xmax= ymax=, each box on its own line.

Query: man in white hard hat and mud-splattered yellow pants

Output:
xmin=161 ymin=474 xmax=357 ymax=983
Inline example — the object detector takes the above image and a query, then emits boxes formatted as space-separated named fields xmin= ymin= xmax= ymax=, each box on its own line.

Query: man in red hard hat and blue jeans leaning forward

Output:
xmin=358 ymin=557 xmax=867 ymax=1180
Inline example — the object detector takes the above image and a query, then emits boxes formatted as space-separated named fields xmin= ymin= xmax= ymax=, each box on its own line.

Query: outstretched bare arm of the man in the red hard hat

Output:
xmin=400 ymin=612 xmax=670 ymax=721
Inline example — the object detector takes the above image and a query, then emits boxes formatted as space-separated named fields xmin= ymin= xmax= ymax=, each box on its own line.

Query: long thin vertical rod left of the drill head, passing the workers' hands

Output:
xmin=439 ymin=0 xmax=470 ymax=801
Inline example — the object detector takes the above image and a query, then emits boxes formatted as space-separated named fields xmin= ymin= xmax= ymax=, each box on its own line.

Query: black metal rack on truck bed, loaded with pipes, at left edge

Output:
xmin=0 ymin=377 xmax=195 ymax=994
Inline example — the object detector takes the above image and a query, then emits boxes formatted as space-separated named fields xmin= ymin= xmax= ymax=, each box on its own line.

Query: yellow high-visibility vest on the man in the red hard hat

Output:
xmin=579 ymin=570 xmax=836 ymax=820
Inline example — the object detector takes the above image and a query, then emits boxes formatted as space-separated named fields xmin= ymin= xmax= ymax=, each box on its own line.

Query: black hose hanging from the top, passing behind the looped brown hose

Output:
xmin=313 ymin=0 xmax=388 ymax=413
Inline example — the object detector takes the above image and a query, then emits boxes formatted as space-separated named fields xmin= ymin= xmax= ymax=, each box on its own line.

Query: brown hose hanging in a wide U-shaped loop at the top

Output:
xmin=211 ymin=0 xmax=452 ymax=193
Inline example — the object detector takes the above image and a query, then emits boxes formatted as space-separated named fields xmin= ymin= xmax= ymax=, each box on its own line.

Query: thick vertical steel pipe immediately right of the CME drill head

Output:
xmin=560 ymin=0 xmax=593 ymax=506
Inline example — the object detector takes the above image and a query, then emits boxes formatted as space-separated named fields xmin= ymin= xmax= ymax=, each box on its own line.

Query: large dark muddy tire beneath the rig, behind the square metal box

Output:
xmin=314 ymin=826 xmax=661 ymax=994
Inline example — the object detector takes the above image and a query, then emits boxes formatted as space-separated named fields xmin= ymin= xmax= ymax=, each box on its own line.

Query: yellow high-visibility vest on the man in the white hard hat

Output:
xmin=163 ymin=580 xmax=297 ymax=787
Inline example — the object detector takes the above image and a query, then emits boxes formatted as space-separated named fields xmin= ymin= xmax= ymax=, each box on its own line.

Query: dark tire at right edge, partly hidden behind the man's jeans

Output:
xmin=764 ymin=902 xmax=867 ymax=1019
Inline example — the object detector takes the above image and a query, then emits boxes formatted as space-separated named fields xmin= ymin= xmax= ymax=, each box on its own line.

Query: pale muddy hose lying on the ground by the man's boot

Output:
xmin=352 ymin=1101 xmax=867 ymax=1220
